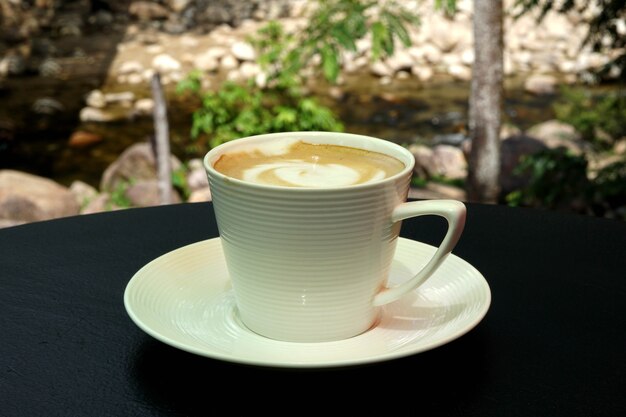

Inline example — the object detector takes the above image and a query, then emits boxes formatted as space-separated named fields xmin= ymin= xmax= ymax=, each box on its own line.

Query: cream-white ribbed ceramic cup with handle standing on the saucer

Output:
xmin=204 ymin=132 xmax=465 ymax=342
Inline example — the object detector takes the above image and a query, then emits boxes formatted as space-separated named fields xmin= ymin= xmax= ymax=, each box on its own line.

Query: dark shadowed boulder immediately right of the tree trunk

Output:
xmin=499 ymin=135 xmax=547 ymax=196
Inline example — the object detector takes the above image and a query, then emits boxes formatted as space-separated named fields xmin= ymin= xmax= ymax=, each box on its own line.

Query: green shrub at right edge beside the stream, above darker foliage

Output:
xmin=554 ymin=88 xmax=626 ymax=147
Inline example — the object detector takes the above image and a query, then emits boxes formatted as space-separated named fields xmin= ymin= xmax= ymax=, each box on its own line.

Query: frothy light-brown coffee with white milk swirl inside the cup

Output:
xmin=213 ymin=141 xmax=405 ymax=188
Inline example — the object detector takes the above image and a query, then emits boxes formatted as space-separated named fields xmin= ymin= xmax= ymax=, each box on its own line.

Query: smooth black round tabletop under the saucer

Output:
xmin=0 ymin=203 xmax=626 ymax=417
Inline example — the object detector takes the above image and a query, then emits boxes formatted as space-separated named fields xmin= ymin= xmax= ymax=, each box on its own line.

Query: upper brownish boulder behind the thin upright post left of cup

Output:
xmin=100 ymin=143 xmax=181 ymax=191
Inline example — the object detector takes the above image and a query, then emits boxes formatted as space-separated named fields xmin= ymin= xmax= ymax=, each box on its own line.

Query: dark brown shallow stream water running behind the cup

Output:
xmin=0 ymin=67 xmax=556 ymax=185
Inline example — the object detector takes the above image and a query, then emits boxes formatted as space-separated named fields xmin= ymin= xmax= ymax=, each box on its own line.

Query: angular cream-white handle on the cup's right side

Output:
xmin=374 ymin=200 xmax=466 ymax=306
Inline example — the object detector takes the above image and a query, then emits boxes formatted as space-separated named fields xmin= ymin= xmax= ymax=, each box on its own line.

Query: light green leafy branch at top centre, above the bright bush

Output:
xmin=250 ymin=0 xmax=420 ymax=87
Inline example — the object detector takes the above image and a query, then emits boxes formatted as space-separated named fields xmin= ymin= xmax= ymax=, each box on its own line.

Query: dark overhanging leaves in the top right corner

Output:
xmin=516 ymin=0 xmax=626 ymax=81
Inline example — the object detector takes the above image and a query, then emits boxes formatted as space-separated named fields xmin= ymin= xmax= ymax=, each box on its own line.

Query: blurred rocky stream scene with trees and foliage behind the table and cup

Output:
xmin=0 ymin=0 xmax=626 ymax=227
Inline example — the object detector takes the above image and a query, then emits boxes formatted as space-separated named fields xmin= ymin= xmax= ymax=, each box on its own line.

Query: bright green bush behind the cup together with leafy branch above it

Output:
xmin=177 ymin=0 xmax=417 ymax=147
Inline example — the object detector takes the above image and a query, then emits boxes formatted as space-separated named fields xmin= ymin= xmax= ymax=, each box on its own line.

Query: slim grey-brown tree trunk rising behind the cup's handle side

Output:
xmin=467 ymin=0 xmax=503 ymax=203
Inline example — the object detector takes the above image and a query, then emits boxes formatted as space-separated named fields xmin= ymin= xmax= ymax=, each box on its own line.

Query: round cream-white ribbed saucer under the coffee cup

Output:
xmin=124 ymin=238 xmax=491 ymax=368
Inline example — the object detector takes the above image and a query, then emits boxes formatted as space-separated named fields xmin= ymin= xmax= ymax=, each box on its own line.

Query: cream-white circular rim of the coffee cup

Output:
xmin=202 ymin=131 xmax=415 ymax=193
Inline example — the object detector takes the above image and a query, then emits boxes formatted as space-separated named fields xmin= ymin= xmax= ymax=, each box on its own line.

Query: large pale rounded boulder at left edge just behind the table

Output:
xmin=0 ymin=169 xmax=79 ymax=222
